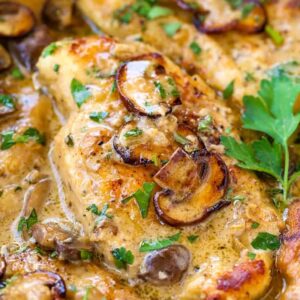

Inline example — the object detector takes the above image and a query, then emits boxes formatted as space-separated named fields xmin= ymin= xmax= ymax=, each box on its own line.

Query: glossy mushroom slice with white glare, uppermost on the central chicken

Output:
xmin=116 ymin=53 xmax=181 ymax=117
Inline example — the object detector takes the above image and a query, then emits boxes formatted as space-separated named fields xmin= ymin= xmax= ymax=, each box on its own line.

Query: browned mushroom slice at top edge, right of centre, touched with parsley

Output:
xmin=176 ymin=0 xmax=267 ymax=33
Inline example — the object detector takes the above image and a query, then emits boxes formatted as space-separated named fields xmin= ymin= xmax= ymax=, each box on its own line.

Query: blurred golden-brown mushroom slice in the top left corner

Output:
xmin=0 ymin=1 xmax=35 ymax=37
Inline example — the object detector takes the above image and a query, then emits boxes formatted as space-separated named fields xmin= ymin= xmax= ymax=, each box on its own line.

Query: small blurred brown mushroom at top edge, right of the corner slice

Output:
xmin=43 ymin=0 xmax=74 ymax=28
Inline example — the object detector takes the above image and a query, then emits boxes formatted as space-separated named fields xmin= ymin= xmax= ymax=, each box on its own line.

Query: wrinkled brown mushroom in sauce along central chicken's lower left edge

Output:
xmin=32 ymin=223 xmax=91 ymax=261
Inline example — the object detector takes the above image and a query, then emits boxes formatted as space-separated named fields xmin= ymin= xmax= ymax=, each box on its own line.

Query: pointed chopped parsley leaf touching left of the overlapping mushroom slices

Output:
xmin=122 ymin=182 xmax=155 ymax=219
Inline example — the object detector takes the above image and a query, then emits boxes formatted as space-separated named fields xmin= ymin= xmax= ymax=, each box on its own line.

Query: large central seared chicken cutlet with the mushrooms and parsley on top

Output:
xmin=38 ymin=36 xmax=280 ymax=299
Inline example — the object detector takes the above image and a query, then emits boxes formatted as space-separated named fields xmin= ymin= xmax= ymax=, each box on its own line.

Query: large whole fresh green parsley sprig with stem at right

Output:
xmin=221 ymin=74 xmax=300 ymax=205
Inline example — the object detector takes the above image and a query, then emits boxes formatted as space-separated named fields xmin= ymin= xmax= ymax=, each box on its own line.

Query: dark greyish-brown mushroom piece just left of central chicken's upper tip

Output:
xmin=10 ymin=25 xmax=53 ymax=71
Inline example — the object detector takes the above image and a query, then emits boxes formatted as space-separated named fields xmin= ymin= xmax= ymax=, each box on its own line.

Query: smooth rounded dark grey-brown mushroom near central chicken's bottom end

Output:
xmin=139 ymin=245 xmax=191 ymax=286
